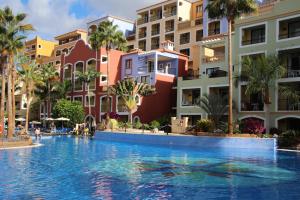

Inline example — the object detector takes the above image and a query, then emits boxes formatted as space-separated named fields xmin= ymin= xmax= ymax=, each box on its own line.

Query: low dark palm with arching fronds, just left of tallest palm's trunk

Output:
xmin=200 ymin=94 xmax=228 ymax=130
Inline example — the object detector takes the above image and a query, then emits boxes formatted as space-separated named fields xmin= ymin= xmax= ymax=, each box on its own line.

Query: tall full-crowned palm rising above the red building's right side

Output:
xmin=90 ymin=21 xmax=126 ymax=119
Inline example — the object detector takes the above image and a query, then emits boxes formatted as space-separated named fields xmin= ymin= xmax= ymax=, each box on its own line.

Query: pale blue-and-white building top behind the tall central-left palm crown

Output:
xmin=87 ymin=15 xmax=135 ymax=50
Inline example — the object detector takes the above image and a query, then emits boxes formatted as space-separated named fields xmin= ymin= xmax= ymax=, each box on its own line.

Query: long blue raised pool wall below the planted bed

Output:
xmin=94 ymin=131 xmax=277 ymax=151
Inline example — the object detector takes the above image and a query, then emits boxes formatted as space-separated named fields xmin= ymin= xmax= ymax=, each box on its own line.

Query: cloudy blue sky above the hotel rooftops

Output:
xmin=0 ymin=0 xmax=161 ymax=40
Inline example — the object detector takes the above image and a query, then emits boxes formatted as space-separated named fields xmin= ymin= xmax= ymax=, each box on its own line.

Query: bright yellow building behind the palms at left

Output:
xmin=25 ymin=36 xmax=57 ymax=64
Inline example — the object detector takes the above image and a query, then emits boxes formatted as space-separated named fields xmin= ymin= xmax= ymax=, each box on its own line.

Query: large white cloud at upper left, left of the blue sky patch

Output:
xmin=0 ymin=0 xmax=85 ymax=39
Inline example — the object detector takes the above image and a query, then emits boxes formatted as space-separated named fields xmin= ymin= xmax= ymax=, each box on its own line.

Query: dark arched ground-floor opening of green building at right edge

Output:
xmin=276 ymin=116 xmax=300 ymax=131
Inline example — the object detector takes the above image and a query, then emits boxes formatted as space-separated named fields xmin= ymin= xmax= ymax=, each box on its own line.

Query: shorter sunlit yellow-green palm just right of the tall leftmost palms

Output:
xmin=18 ymin=57 xmax=43 ymax=133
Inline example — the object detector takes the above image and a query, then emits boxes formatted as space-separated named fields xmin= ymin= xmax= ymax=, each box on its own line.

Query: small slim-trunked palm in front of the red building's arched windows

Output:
xmin=76 ymin=70 xmax=101 ymax=115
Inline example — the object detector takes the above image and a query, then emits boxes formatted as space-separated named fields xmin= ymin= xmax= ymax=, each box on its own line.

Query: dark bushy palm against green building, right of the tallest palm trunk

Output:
xmin=238 ymin=55 xmax=286 ymax=133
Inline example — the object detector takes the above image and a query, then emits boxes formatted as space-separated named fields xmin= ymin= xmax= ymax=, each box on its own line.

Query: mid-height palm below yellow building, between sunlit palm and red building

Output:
xmin=36 ymin=64 xmax=59 ymax=119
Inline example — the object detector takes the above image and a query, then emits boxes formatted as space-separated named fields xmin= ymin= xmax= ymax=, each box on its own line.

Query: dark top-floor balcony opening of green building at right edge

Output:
xmin=279 ymin=17 xmax=300 ymax=40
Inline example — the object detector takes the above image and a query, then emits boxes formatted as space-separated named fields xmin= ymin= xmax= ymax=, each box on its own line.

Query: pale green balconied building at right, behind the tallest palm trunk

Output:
xmin=177 ymin=0 xmax=300 ymax=130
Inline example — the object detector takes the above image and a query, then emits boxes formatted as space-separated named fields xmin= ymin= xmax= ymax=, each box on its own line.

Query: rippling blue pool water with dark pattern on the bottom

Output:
xmin=0 ymin=137 xmax=300 ymax=200
